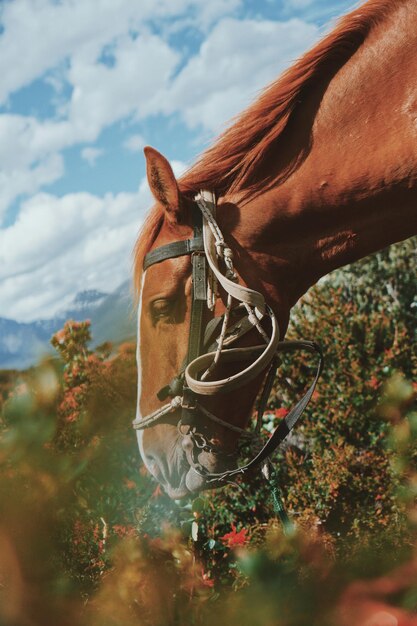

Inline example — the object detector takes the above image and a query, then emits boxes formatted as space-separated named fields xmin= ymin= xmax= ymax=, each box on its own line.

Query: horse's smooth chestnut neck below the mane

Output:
xmin=234 ymin=0 xmax=417 ymax=306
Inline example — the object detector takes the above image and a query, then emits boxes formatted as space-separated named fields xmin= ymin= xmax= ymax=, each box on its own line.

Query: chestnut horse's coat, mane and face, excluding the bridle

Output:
xmin=135 ymin=0 xmax=417 ymax=498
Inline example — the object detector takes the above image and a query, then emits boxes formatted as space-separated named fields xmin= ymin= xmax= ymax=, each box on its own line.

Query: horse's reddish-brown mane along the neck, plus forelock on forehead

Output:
xmin=134 ymin=0 xmax=404 ymax=288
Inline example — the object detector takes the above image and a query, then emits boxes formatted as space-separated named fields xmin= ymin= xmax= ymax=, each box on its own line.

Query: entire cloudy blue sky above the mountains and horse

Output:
xmin=0 ymin=0 xmax=355 ymax=322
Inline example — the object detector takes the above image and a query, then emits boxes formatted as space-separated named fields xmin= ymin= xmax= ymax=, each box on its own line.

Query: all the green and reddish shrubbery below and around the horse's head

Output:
xmin=0 ymin=240 xmax=417 ymax=626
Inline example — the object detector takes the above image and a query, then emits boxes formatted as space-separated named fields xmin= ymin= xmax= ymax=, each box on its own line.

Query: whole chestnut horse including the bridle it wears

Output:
xmin=134 ymin=0 xmax=417 ymax=499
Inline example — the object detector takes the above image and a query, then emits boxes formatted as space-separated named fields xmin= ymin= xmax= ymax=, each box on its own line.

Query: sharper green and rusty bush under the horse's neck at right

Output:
xmin=272 ymin=240 xmax=417 ymax=536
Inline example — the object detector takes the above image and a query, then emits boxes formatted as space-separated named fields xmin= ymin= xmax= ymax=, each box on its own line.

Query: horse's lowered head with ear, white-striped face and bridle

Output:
xmin=135 ymin=148 xmax=300 ymax=498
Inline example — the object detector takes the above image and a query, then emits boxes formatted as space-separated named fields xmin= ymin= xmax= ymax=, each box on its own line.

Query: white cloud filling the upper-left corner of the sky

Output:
xmin=0 ymin=0 xmax=247 ymax=221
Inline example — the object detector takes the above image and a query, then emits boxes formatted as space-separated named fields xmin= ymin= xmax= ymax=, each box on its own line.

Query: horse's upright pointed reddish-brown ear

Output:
xmin=143 ymin=146 xmax=180 ymax=223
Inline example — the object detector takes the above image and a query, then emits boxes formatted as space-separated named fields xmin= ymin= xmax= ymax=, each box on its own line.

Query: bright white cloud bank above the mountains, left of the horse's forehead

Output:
xmin=0 ymin=161 xmax=185 ymax=321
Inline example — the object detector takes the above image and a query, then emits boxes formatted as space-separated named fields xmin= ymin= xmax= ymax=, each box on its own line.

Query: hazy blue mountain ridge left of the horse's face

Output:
xmin=0 ymin=281 xmax=136 ymax=369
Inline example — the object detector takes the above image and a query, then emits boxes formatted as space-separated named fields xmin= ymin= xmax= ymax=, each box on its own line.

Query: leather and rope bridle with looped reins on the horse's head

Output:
xmin=133 ymin=191 xmax=323 ymax=484
